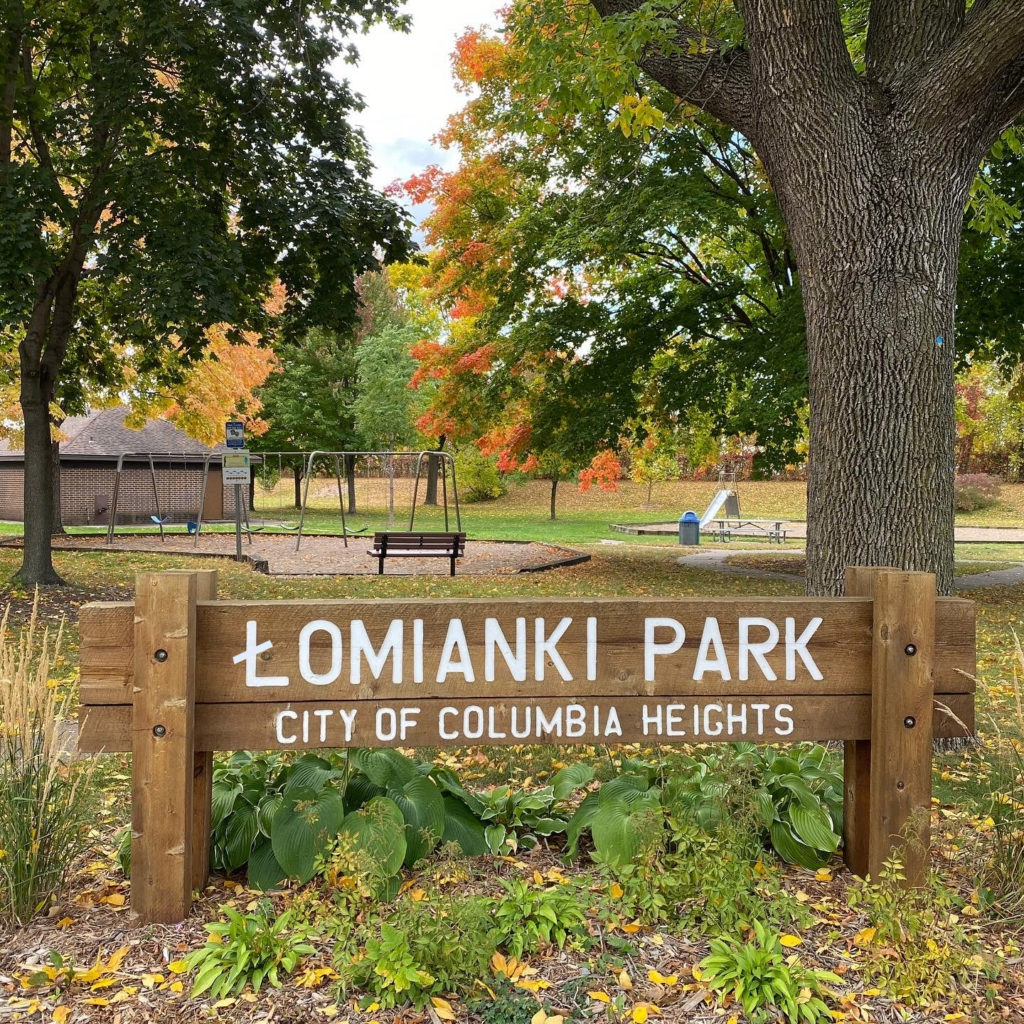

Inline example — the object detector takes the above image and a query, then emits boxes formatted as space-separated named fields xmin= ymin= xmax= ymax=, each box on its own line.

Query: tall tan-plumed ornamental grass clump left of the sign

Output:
xmin=0 ymin=605 xmax=92 ymax=925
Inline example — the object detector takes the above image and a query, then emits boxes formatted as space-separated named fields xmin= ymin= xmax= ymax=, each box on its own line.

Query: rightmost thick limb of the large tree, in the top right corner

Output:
xmin=905 ymin=0 xmax=1024 ymax=153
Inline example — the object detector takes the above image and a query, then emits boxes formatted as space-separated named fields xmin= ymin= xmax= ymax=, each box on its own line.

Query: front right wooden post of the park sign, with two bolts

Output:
xmin=867 ymin=569 xmax=935 ymax=885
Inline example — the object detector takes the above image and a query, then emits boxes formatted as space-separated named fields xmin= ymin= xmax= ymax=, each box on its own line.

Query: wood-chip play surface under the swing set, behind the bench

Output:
xmin=54 ymin=531 xmax=590 ymax=577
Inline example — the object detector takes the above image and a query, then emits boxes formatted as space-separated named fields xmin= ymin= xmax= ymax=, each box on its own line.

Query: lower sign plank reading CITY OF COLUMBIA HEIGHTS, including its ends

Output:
xmin=79 ymin=694 xmax=974 ymax=752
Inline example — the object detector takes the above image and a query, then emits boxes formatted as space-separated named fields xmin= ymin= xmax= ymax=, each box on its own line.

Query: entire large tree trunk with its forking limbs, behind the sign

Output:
xmin=592 ymin=0 xmax=1024 ymax=594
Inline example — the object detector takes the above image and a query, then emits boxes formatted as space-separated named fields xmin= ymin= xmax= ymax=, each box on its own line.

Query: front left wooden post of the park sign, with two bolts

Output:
xmin=131 ymin=572 xmax=198 ymax=923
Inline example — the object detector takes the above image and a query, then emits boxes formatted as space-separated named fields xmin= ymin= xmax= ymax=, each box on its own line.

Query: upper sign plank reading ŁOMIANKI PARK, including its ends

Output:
xmin=81 ymin=598 xmax=975 ymax=705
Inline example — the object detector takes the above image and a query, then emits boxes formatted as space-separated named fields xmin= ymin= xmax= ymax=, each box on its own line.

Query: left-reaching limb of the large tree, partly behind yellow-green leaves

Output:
xmin=590 ymin=0 xmax=753 ymax=134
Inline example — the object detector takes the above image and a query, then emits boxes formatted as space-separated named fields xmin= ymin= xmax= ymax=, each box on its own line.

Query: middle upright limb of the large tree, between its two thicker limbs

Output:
xmin=865 ymin=0 xmax=964 ymax=85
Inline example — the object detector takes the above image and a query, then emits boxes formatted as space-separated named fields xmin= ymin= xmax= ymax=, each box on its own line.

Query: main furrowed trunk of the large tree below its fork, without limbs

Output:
xmin=760 ymin=98 xmax=976 ymax=594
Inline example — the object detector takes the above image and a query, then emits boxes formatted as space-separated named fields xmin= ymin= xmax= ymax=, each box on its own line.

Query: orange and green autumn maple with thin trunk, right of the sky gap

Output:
xmin=402 ymin=32 xmax=620 ymax=518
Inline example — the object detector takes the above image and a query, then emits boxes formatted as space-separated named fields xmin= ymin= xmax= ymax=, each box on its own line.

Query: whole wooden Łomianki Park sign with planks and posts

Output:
xmin=79 ymin=568 xmax=975 ymax=921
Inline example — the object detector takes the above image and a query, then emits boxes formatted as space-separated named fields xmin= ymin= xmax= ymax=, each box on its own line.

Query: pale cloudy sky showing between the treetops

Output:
xmin=339 ymin=0 xmax=501 ymax=201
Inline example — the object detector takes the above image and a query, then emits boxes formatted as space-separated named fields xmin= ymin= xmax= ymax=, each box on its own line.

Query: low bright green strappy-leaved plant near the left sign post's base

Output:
xmin=185 ymin=900 xmax=315 ymax=999
